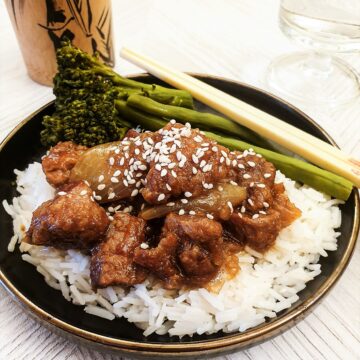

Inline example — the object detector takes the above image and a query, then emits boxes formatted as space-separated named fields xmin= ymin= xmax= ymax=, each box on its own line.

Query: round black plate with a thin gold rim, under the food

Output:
xmin=0 ymin=75 xmax=359 ymax=357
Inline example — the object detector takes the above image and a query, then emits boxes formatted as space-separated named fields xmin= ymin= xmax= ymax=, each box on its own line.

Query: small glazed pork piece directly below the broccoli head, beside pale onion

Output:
xmin=42 ymin=141 xmax=87 ymax=188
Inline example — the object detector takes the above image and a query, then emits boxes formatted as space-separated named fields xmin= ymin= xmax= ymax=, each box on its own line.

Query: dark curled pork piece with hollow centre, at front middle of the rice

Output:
xmin=134 ymin=213 xmax=224 ymax=289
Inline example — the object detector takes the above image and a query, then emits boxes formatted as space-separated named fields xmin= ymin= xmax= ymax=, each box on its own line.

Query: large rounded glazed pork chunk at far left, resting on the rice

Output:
xmin=24 ymin=182 xmax=109 ymax=249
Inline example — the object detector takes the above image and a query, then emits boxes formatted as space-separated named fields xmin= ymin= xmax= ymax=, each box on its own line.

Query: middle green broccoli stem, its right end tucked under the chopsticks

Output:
xmin=127 ymin=94 xmax=273 ymax=148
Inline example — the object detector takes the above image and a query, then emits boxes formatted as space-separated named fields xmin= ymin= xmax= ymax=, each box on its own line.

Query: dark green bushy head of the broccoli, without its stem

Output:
xmin=40 ymin=43 xmax=130 ymax=146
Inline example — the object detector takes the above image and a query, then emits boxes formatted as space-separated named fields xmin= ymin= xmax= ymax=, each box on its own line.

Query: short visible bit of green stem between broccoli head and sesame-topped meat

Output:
xmin=115 ymin=100 xmax=167 ymax=131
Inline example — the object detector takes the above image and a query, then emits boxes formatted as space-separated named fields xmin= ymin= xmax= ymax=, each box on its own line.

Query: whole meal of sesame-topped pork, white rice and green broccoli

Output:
xmin=3 ymin=44 xmax=351 ymax=336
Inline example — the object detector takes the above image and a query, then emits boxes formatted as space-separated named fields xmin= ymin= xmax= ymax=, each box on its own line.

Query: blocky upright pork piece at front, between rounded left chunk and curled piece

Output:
xmin=90 ymin=212 xmax=147 ymax=288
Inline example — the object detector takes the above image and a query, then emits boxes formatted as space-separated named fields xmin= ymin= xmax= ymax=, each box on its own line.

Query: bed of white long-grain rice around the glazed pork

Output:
xmin=3 ymin=162 xmax=341 ymax=337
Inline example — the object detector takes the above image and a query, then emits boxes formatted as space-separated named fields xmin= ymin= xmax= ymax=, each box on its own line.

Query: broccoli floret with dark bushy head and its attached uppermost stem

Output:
xmin=41 ymin=42 xmax=193 ymax=146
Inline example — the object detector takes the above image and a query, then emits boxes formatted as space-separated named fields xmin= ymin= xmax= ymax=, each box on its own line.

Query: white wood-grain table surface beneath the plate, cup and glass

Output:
xmin=0 ymin=0 xmax=360 ymax=360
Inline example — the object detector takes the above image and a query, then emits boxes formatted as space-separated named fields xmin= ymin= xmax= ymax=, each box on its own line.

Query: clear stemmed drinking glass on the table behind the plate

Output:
xmin=266 ymin=0 xmax=360 ymax=105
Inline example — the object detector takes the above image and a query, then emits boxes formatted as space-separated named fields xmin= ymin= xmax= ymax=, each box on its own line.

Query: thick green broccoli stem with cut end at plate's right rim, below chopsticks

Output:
xmin=205 ymin=132 xmax=353 ymax=200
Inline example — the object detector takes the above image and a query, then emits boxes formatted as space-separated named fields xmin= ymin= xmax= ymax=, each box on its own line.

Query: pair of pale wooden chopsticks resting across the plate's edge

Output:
xmin=121 ymin=48 xmax=360 ymax=187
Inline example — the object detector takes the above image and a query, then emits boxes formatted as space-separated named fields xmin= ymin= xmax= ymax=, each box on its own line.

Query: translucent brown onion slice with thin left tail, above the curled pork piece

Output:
xmin=139 ymin=184 xmax=246 ymax=220
